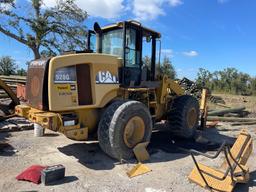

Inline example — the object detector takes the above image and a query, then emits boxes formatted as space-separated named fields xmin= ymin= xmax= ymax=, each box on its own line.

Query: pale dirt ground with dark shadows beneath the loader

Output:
xmin=0 ymin=95 xmax=256 ymax=192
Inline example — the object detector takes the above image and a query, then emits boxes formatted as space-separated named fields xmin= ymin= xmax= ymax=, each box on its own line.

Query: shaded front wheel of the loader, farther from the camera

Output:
xmin=168 ymin=95 xmax=199 ymax=138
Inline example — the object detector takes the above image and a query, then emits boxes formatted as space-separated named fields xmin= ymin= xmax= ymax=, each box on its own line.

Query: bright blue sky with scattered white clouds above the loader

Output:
xmin=0 ymin=0 xmax=256 ymax=79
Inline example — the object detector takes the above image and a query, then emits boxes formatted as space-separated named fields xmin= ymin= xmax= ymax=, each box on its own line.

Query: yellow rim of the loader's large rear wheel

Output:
xmin=124 ymin=116 xmax=145 ymax=148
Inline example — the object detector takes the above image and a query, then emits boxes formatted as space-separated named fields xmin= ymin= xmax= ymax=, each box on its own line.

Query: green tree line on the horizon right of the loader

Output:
xmin=196 ymin=67 xmax=256 ymax=95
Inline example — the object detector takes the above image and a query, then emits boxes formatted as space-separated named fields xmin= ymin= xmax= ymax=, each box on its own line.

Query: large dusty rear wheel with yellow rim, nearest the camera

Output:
xmin=98 ymin=101 xmax=152 ymax=160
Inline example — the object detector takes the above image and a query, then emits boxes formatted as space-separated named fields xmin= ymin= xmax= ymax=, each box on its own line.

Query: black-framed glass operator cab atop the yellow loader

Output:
xmin=87 ymin=21 xmax=161 ymax=86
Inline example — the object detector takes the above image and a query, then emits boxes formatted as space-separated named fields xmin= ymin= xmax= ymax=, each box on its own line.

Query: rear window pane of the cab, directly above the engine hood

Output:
xmin=102 ymin=29 xmax=123 ymax=57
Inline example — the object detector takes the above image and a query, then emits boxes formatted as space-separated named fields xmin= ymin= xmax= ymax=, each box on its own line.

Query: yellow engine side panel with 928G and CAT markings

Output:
xmin=48 ymin=53 xmax=121 ymax=111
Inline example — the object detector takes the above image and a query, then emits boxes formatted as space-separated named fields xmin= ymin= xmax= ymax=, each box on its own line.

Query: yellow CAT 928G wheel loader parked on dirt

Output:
xmin=15 ymin=21 xmax=199 ymax=160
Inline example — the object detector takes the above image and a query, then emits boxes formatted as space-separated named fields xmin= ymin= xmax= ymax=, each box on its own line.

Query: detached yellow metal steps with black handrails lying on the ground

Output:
xmin=188 ymin=130 xmax=253 ymax=192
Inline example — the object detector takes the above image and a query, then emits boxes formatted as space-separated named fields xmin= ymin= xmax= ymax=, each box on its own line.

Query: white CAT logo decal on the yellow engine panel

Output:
xmin=96 ymin=71 xmax=119 ymax=84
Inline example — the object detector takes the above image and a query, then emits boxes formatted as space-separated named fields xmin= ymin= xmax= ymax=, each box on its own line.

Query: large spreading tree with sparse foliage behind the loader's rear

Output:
xmin=0 ymin=0 xmax=87 ymax=59
